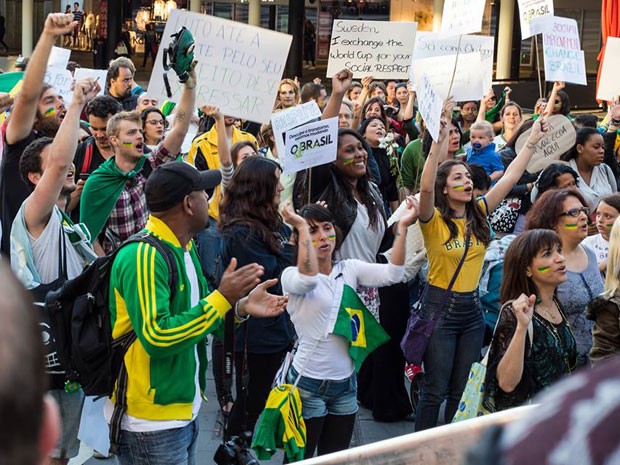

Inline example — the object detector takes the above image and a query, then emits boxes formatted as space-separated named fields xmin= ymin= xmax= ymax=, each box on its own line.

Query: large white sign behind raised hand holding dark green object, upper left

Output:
xmin=148 ymin=9 xmax=292 ymax=123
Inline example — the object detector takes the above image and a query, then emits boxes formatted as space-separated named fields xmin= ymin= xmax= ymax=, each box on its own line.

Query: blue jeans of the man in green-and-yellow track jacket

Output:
xmin=118 ymin=420 xmax=198 ymax=465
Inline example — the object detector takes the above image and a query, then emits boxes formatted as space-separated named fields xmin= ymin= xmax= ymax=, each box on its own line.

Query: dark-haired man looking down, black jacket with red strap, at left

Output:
xmin=67 ymin=95 xmax=123 ymax=222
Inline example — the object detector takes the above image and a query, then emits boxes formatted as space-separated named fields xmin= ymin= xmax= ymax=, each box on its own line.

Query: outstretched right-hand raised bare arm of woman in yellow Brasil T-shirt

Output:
xmin=486 ymin=116 xmax=547 ymax=212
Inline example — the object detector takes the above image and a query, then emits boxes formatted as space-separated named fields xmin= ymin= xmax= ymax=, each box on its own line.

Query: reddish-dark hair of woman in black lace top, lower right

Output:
xmin=501 ymin=229 xmax=562 ymax=303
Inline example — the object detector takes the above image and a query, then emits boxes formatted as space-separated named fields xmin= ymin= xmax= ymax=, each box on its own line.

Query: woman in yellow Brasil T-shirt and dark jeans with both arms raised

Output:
xmin=416 ymin=99 xmax=546 ymax=431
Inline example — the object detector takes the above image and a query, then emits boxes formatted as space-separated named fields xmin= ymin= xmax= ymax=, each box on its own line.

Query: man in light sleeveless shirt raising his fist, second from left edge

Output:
xmin=11 ymin=79 xmax=100 ymax=465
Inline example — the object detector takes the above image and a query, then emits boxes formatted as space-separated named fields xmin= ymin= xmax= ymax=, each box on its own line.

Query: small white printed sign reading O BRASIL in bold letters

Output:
xmin=278 ymin=117 xmax=338 ymax=174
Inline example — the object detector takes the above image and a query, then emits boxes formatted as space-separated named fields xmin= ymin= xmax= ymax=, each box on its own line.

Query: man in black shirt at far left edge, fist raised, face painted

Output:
xmin=0 ymin=13 xmax=75 ymax=255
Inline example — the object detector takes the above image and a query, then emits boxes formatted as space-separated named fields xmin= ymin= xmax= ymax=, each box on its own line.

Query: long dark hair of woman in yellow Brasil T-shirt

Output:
xmin=435 ymin=160 xmax=491 ymax=246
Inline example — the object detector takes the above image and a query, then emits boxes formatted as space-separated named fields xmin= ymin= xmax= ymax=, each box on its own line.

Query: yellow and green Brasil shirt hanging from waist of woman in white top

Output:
xmin=252 ymin=384 xmax=306 ymax=462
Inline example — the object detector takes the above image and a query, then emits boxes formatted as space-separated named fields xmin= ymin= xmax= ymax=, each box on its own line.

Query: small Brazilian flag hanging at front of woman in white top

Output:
xmin=331 ymin=284 xmax=390 ymax=372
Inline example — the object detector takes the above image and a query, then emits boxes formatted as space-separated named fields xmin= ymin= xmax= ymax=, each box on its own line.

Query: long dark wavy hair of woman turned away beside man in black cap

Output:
xmin=218 ymin=157 xmax=284 ymax=254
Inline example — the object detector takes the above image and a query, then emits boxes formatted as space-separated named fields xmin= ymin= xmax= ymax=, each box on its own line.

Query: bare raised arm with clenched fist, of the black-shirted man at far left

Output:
xmin=6 ymin=13 xmax=77 ymax=145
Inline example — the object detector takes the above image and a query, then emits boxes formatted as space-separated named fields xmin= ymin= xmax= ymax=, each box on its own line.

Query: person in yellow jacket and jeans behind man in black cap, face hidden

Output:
xmin=187 ymin=110 xmax=258 ymax=276
